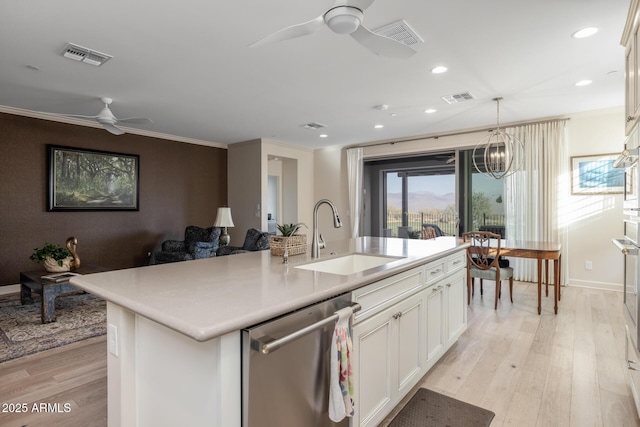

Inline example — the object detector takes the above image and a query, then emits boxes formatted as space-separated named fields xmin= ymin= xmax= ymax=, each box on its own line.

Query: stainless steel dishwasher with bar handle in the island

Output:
xmin=242 ymin=293 xmax=360 ymax=427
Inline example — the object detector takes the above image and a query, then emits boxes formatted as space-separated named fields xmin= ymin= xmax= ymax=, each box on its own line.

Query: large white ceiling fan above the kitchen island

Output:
xmin=249 ymin=0 xmax=416 ymax=58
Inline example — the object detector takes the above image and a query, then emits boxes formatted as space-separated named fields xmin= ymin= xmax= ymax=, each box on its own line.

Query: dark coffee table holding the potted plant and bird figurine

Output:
xmin=20 ymin=265 xmax=107 ymax=323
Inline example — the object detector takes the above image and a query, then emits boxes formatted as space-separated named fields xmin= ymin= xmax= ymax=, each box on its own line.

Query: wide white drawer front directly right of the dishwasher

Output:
xmin=351 ymin=267 xmax=424 ymax=324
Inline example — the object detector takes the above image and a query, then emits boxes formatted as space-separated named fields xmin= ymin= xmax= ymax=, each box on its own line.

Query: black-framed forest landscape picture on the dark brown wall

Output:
xmin=47 ymin=145 xmax=140 ymax=211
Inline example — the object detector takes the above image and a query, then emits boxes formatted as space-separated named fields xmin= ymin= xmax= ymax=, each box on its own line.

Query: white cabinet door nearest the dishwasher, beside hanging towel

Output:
xmin=351 ymin=310 xmax=397 ymax=426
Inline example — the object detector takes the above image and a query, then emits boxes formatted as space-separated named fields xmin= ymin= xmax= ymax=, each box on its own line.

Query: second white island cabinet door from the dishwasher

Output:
xmin=392 ymin=294 xmax=425 ymax=397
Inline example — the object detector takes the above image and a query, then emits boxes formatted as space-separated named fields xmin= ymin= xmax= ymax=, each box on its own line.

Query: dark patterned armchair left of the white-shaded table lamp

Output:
xmin=154 ymin=225 xmax=221 ymax=264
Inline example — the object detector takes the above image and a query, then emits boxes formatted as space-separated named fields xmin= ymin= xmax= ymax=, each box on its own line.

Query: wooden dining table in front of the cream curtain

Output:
xmin=500 ymin=239 xmax=562 ymax=314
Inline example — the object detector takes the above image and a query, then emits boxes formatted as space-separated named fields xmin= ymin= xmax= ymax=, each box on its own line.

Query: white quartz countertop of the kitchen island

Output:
xmin=71 ymin=237 xmax=467 ymax=341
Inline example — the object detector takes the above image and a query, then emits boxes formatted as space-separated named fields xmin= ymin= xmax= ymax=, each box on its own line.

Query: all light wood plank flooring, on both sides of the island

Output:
xmin=0 ymin=282 xmax=640 ymax=427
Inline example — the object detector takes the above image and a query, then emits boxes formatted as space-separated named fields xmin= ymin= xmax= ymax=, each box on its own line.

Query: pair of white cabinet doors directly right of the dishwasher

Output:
xmin=352 ymin=293 xmax=425 ymax=426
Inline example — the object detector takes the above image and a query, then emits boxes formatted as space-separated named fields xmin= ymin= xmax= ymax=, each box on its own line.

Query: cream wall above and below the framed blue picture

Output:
xmin=564 ymin=107 xmax=625 ymax=290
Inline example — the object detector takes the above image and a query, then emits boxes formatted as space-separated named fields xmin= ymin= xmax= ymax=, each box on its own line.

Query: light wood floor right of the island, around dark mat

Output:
xmin=382 ymin=281 xmax=640 ymax=427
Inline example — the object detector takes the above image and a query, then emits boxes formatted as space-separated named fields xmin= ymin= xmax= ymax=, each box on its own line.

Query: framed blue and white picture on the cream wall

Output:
xmin=571 ymin=154 xmax=624 ymax=194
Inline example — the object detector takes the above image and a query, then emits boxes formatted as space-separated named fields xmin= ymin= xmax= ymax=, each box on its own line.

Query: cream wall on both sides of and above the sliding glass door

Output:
xmin=314 ymin=107 xmax=624 ymax=290
